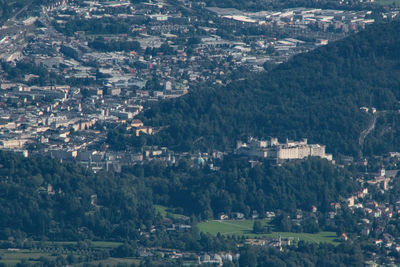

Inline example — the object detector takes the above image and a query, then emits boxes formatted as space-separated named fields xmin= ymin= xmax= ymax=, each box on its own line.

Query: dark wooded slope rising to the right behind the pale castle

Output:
xmin=143 ymin=22 xmax=400 ymax=158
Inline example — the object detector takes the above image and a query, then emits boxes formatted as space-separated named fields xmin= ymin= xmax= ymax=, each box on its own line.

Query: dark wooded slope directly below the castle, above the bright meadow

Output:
xmin=127 ymin=158 xmax=358 ymax=219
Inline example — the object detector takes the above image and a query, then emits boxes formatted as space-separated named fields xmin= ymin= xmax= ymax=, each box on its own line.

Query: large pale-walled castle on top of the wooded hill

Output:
xmin=236 ymin=137 xmax=332 ymax=161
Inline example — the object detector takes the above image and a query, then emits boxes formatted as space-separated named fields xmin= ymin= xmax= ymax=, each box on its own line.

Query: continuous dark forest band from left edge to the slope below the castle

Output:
xmin=0 ymin=152 xmax=358 ymax=241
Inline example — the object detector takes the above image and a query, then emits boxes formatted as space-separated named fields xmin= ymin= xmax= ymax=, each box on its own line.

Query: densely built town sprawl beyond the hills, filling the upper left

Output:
xmin=0 ymin=1 xmax=398 ymax=170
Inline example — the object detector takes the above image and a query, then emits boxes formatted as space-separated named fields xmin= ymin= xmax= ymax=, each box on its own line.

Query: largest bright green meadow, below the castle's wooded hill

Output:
xmin=197 ymin=220 xmax=337 ymax=244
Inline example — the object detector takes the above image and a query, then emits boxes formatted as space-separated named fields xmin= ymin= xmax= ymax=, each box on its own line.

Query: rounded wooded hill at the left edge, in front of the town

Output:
xmin=0 ymin=152 xmax=155 ymax=240
